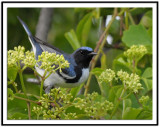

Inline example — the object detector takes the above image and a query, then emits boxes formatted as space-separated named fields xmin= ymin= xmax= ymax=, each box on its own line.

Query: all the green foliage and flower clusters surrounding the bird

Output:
xmin=7 ymin=8 xmax=152 ymax=120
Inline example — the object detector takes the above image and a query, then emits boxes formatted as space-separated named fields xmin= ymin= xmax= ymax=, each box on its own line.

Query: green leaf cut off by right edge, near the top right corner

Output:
xmin=140 ymin=10 xmax=152 ymax=28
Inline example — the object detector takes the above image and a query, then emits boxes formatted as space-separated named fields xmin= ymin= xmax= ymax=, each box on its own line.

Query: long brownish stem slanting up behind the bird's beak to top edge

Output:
xmin=84 ymin=8 xmax=117 ymax=96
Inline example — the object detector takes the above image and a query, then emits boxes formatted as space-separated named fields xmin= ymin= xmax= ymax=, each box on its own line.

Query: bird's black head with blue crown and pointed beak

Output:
xmin=73 ymin=47 xmax=97 ymax=68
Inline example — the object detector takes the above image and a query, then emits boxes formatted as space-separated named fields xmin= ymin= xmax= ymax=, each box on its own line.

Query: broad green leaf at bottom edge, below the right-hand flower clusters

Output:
xmin=122 ymin=107 xmax=142 ymax=120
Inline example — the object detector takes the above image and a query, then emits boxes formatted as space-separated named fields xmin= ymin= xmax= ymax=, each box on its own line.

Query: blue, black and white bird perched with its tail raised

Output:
xmin=17 ymin=16 xmax=97 ymax=93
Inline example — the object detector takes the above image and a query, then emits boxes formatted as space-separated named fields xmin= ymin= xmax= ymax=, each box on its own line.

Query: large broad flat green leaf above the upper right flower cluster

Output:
xmin=122 ymin=24 xmax=152 ymax=47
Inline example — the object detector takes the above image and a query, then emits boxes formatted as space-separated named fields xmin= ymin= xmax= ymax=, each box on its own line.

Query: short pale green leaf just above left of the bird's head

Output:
xmin=65 ymin=29 xmax=81 ymax=50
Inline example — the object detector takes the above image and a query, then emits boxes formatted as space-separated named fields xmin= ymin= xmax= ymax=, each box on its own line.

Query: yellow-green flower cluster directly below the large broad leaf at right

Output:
xmin=124 ymin=45 xmax=147 ymax=60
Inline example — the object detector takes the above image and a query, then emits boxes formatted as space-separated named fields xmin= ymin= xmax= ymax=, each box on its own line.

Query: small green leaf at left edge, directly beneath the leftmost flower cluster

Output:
xmin=7 ymin=67 xmax=18 ymax=81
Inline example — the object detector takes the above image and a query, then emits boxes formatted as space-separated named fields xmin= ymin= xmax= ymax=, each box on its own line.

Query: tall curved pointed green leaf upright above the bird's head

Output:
xmin=76 ymin=12 xmax=93 ymax=46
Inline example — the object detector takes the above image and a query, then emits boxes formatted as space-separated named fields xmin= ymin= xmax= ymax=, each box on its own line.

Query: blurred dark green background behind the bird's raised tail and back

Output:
xmin=7 ymin=8 xmax=98 ymax=53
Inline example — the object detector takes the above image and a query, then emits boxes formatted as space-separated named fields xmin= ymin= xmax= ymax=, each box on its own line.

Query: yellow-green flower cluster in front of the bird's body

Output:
xmin=38 ymin=52 xmax=69 ymax=73
